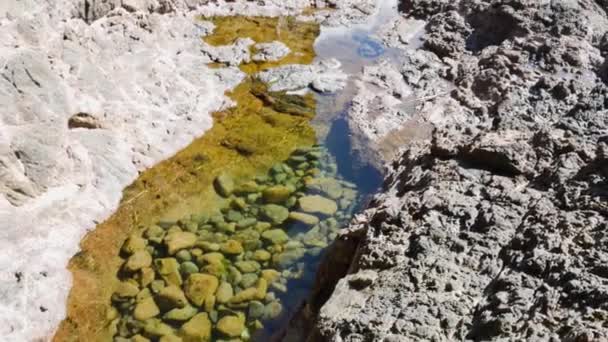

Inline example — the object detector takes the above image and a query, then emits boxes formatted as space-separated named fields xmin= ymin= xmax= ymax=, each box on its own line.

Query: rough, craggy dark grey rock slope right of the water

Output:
xmin=318 ymin=0 xmax=608 ymax=341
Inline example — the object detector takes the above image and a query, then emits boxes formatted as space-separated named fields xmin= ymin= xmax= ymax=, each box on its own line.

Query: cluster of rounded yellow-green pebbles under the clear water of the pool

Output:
xmin=109 ymin=146 xmax=359 ymax=342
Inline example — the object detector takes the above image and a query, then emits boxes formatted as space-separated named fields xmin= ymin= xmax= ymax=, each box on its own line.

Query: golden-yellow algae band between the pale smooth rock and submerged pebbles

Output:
xmin=54 ymin=17 xmax=319 ymax=341
